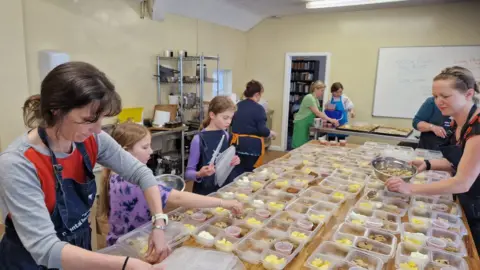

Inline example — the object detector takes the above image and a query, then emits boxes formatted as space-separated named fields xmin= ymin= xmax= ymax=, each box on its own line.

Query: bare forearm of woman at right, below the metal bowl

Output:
xmin=411 ymin=177 xmax=466 ymax=195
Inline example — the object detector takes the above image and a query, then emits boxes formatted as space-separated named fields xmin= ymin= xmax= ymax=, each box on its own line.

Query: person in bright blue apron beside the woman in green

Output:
xmin=325 ymin=82 xmax=355 ymax=140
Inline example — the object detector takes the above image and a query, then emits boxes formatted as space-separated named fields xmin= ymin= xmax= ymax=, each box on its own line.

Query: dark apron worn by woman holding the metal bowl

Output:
xmin=440 ymin=105 xmax=480 ymax=252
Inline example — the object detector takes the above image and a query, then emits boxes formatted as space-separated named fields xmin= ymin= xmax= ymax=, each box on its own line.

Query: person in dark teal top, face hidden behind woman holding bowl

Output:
xmin=412 ymin=97 xmax=451 ymax=151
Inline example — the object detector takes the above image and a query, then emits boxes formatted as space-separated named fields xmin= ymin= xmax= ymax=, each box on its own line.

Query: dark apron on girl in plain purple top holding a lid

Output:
xmin=193 ymin=130 xmax=234 ymax=195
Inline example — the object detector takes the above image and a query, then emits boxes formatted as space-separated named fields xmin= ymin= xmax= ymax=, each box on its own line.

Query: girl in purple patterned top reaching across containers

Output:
xmin=101 ymin=122 xmax=242 ymax=245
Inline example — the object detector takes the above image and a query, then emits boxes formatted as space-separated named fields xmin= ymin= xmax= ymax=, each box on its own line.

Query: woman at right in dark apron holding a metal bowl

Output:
xmin=386 ymin=67 xmax=480 ymax=250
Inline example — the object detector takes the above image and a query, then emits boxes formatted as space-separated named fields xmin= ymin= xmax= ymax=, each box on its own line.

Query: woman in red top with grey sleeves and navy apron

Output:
xmin=0 ymin=62 xmax=170 ymax=270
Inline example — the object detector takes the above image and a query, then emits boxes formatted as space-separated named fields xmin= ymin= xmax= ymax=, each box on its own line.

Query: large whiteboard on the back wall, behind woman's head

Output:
xmin=373 ymin=46 xmax=480 ymax=118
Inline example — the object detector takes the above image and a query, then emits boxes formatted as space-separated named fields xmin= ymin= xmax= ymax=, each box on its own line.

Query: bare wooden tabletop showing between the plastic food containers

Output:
xmin=183 ymin=141 xmax=480 ymax=270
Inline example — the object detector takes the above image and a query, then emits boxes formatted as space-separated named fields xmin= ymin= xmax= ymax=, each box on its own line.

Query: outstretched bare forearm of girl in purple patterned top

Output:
xmin=168 ymin=190 xmax=222 ymax=208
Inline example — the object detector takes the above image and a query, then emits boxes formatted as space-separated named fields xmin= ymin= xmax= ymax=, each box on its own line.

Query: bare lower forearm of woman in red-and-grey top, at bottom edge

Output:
xmin=62 ymin=244 xmax=131 ymax=270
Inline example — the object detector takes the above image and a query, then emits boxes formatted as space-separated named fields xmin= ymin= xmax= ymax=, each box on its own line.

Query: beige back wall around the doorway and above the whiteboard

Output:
xmin=246 ymin=2 xmax=480 ymax=148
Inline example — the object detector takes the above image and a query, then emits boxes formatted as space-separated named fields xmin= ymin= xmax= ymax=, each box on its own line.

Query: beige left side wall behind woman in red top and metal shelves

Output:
xmin=0 ymin=0 xmax=246 ymax=150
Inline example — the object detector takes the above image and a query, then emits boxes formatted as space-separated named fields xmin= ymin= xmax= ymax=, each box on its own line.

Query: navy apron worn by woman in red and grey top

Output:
xmin=0 ymin=128 xmax=97 ymax=270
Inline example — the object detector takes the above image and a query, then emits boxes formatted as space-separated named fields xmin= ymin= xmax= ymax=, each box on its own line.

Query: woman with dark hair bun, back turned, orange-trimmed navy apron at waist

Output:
xmin=232 ymin=80 xmax=277 ymax=174
